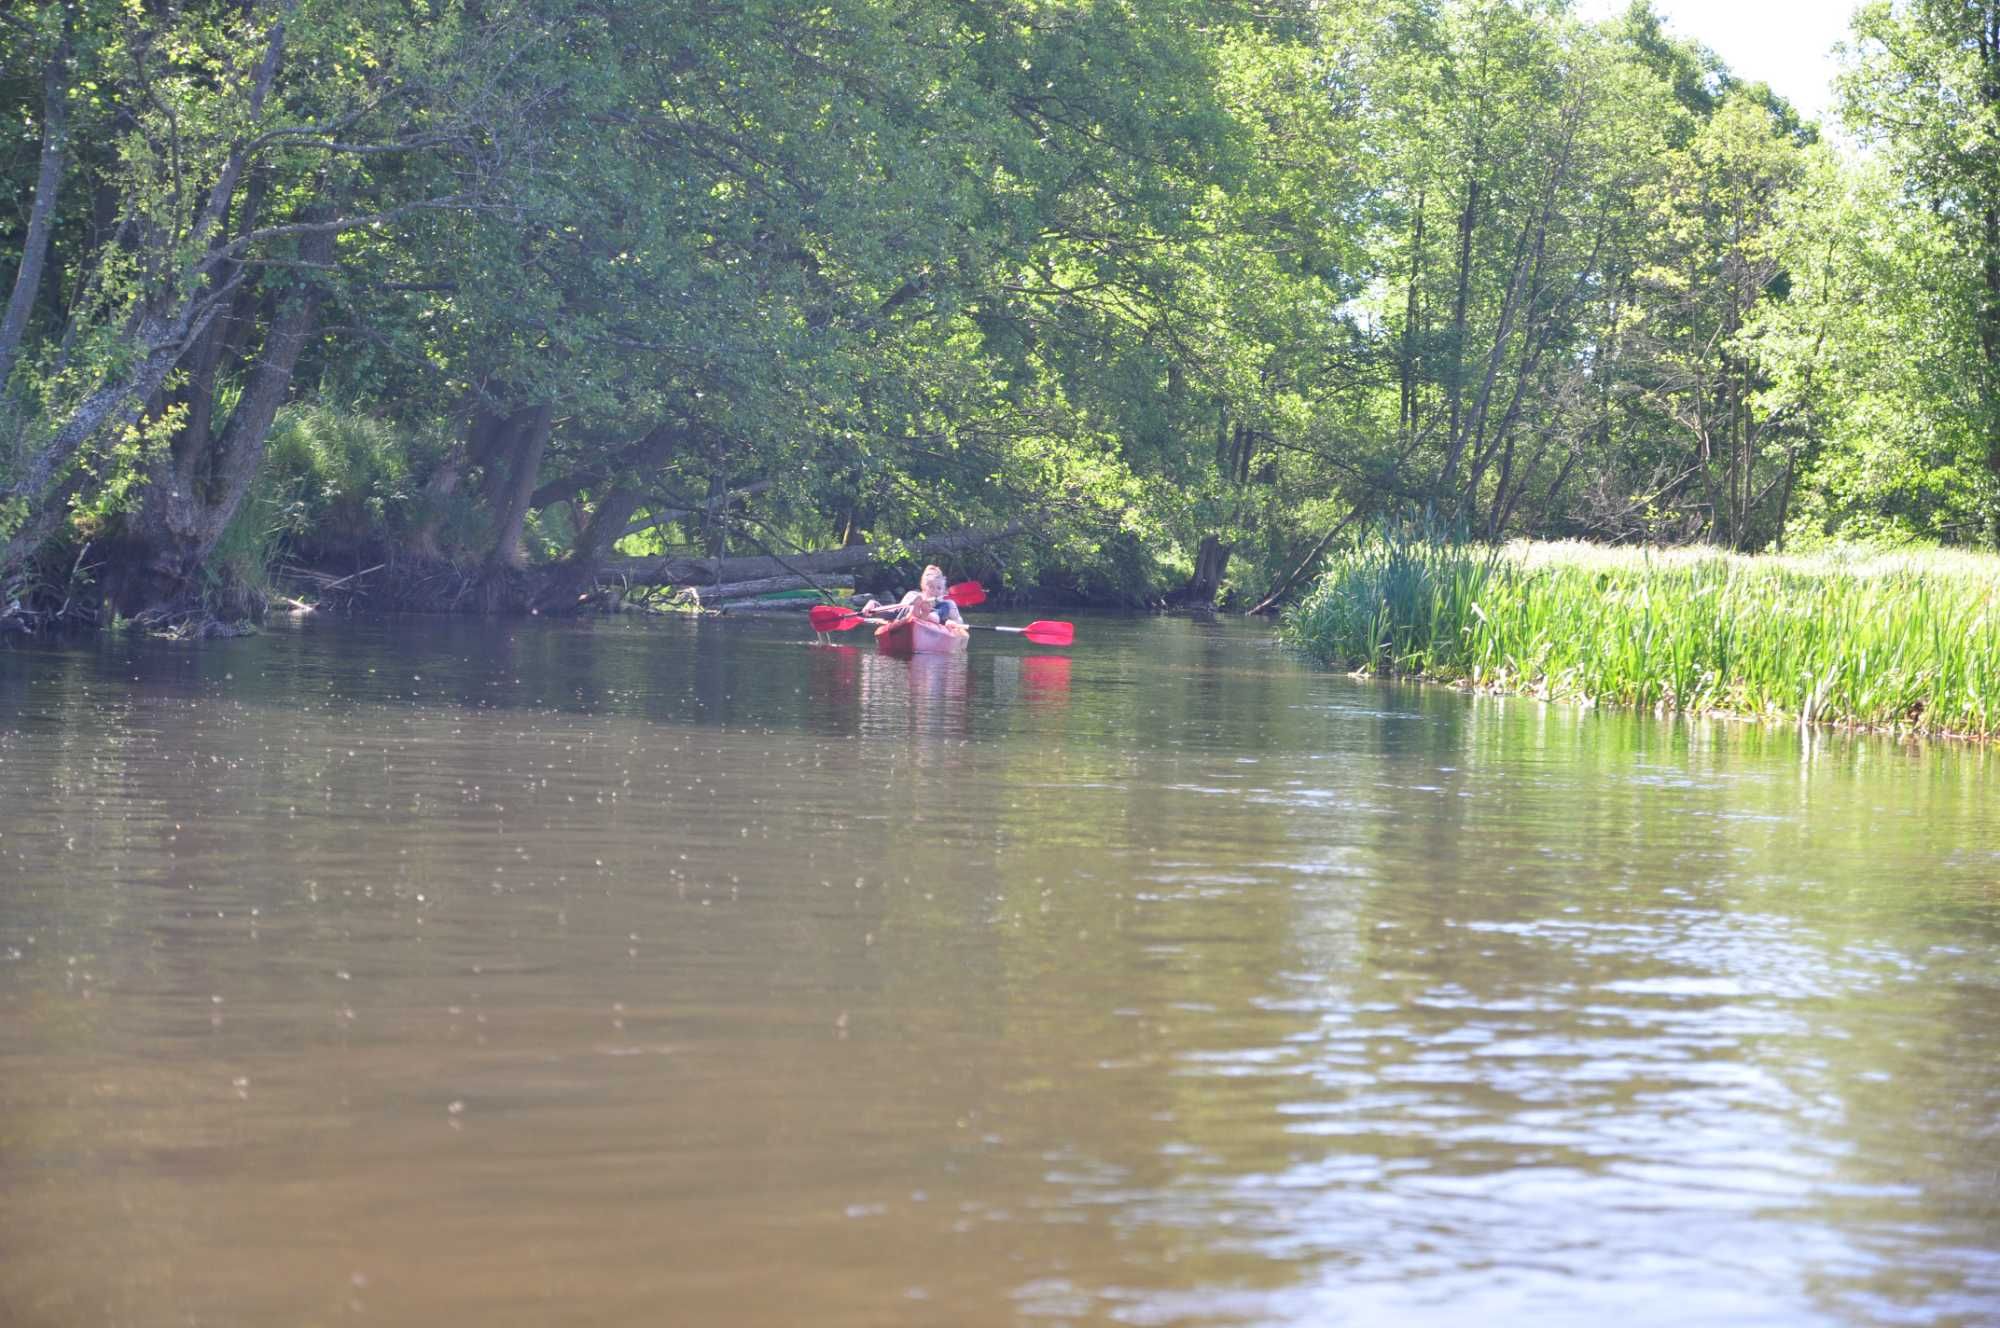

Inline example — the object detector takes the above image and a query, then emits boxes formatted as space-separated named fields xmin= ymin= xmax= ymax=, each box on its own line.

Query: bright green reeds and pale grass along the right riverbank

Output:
xmin=1284 ymin=534 xmax=2000 ymax=738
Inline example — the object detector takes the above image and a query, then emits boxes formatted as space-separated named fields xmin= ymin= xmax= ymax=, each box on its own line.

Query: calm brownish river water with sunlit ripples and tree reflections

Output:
xmin=0 ymin=616 xmax=2000 ymax=1328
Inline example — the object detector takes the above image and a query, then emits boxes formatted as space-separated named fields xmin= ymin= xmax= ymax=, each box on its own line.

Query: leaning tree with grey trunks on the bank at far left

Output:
xmin=0 ymin=0 xmax=580 ymax=614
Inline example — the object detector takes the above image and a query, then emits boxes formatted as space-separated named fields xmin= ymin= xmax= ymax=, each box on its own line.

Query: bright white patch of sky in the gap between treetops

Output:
xmin=1576 ymin=0 xmax=1856 ymax=116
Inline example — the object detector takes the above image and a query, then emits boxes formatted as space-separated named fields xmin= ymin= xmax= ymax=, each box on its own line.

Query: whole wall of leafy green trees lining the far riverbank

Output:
xmin=0 ymin=0 xmax=2000 ymax=622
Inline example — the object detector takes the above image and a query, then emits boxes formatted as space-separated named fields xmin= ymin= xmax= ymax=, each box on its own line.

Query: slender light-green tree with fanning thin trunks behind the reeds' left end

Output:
xmin=1378 ymin=0 xmax=1682 ymax=538
